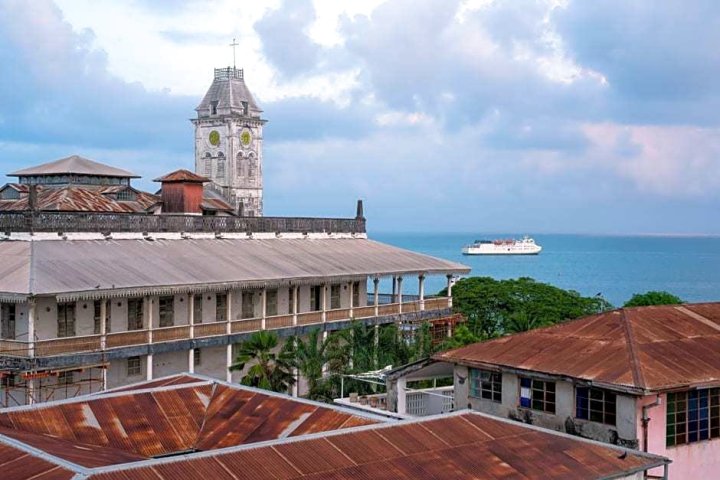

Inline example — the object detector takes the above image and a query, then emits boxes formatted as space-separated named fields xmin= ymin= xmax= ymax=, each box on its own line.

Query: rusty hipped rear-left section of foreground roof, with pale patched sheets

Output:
xmin=0 ymin=375 xmax=380 ymax=480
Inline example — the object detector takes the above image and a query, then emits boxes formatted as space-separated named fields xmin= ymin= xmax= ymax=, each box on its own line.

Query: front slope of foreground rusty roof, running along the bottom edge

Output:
xmin=90 ymin=412 xmax=668 ymax=480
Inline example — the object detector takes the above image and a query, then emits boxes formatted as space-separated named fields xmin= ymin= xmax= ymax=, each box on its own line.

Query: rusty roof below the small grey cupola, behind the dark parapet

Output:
xmin=0 ymin=184 xmax=159 ymax=213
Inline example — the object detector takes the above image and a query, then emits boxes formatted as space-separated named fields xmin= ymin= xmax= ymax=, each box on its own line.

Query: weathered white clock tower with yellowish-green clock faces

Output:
xmin=192 ymin=67 xmax=267 ymax=217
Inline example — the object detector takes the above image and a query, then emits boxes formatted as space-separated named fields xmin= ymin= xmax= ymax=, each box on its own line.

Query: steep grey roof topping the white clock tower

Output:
xmin=195 ymin=67 xmax=262 ymax=117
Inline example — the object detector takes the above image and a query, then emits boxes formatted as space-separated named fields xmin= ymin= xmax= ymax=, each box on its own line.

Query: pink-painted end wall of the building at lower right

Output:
xmin=636 ymin=394 xmax=720 ymax=480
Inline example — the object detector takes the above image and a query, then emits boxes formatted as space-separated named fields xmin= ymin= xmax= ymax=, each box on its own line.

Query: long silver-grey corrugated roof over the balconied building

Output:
xmin=0 ymin=238 xmax=470 ymax=298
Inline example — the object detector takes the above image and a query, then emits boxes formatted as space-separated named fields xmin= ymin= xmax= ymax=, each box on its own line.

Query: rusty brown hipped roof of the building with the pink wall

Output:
xmin=434 ymin=303 xmax=720 ymax=394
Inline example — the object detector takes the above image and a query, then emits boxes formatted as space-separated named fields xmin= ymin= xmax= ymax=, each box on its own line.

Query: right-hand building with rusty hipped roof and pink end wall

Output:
xmin=408 ymin=303 xmax=720 ymax=479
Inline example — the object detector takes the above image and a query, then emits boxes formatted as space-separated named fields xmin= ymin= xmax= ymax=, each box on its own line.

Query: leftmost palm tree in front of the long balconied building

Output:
xmin=230 ymin=331 xmax=296 ymax=392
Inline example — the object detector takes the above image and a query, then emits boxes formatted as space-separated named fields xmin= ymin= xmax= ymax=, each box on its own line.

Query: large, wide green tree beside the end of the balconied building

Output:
xmin=440 ymin=277 xmax=612 ymax=338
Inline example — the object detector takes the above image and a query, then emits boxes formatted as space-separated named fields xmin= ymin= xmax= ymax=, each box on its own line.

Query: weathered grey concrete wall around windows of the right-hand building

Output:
xmin=454 ymin=365 xmax=639 ymax=448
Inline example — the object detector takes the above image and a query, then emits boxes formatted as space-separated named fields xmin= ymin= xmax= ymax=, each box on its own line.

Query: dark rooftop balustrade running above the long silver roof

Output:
xmin=0 ymin=212 xmax=365 ymax=233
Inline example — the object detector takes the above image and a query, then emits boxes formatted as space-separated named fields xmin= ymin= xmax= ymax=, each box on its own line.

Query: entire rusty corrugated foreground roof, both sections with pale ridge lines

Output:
xmin=0 ymin=374 xmax=669 ymax=480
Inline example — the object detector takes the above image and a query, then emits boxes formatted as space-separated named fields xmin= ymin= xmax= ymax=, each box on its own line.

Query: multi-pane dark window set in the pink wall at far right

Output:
xmin=665 ymin=388 xmax=720 ymax=447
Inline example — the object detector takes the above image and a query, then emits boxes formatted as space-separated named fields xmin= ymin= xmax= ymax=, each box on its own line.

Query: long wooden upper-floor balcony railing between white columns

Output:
xmin=0 ymin=298 xmax=449 ymax=357
